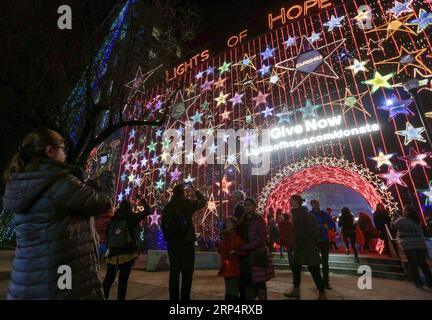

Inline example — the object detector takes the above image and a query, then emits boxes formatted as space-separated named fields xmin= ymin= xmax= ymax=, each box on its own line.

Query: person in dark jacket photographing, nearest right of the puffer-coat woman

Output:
xmin=103 ymin=199 xmax=151 ymax=300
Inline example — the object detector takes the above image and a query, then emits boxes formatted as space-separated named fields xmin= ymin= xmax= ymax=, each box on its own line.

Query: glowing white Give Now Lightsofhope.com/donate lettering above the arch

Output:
xmin=247 ymin=115 xmax=380 ymax=156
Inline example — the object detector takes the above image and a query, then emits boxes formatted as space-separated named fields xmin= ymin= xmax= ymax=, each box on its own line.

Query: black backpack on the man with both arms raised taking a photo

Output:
xmin=161 ymin=205 xmax=188 ymax=242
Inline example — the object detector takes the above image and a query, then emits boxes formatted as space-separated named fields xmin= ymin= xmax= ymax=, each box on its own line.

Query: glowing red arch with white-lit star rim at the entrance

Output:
xmin=258 ymin=157 xmax=397 ymax=214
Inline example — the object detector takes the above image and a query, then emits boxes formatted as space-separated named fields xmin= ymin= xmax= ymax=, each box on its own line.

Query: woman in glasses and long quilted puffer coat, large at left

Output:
xmin=3 ymin=129 xmax=115 ymax=299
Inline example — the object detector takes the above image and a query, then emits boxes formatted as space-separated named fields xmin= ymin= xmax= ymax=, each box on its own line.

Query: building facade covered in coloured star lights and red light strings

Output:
xmin=117 ymin=0 xmax=432 ymax=246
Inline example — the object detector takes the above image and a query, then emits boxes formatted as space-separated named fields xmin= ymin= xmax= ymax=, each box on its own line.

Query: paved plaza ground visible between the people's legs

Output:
xmin=0 ymin=251 xmax=432 ymax=300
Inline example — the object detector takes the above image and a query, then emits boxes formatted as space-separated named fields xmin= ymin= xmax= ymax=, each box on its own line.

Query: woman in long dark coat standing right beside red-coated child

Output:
xmin=237 ymin=198 xmax=275 ymax=300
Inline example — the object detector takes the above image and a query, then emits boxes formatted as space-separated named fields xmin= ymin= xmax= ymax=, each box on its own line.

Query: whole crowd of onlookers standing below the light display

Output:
xmin=3 ymin=129 xmax=432 ymax=300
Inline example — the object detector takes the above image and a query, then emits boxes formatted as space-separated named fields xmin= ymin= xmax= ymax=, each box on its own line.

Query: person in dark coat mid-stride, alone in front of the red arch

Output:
xmin=284 ymin=194 xmax=327 ymax=300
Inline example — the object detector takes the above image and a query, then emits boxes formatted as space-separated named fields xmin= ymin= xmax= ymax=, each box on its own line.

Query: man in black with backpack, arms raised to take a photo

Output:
xmin=162 ymin=184 xmax=207 ymax=301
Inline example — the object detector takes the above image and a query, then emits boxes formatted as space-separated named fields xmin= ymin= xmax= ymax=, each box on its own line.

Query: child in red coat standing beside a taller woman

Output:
xmin=218 ymin=217 xmax=244 ymax=300
